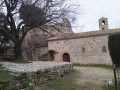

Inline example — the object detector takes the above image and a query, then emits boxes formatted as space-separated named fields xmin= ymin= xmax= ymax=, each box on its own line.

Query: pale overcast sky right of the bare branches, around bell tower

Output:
xmin=72 ymin=0 xmax=120 ymax=32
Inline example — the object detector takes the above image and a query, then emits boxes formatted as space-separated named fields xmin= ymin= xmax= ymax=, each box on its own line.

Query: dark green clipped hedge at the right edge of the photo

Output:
xmin=108 ymin=34 xmax=120 ymax=65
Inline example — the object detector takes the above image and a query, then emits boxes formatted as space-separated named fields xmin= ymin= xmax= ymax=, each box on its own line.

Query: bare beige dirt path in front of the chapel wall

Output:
xmin=74 ymin=67 xmax=113 ymax=90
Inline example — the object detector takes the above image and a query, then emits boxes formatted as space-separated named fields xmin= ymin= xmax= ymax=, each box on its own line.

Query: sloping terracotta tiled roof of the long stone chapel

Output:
xmin=48 ymin=28 xmax=120 ymax=41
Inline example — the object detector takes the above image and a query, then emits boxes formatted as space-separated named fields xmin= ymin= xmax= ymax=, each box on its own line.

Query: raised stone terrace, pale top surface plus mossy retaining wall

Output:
xmin=0 ymin=61 xmax=73 ymax=90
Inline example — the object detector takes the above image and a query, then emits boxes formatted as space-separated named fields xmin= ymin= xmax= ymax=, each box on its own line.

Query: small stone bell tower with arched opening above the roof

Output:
xmin=99 ymin=17 xmax=109 ymax=30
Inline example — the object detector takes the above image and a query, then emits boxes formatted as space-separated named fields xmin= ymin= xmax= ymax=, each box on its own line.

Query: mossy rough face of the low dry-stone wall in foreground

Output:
xmin=0 ymin=63 xmax=73 ymax=90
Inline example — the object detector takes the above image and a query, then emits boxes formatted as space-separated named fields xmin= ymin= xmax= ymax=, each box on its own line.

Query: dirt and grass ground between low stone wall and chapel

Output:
xmin=35 ymin=66 xmax=113 ymax=90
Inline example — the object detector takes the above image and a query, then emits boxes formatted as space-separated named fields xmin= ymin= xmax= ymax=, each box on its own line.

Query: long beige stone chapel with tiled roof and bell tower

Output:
xmin=48 ymin=17 xmax=120 ymax=65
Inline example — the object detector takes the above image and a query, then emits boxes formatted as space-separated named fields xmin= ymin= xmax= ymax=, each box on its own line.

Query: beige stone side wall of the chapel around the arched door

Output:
xmin=48 ymin=35 xmax=112 ymax=65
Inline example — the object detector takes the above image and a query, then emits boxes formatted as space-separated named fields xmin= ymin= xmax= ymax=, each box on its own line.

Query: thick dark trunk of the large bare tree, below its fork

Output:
xmin=14 ymin=42 xmax=23 ymax=60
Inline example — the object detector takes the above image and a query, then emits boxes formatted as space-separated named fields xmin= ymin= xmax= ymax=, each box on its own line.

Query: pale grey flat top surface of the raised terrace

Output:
xmin=0 ymin=61 xmax=69 ymax=72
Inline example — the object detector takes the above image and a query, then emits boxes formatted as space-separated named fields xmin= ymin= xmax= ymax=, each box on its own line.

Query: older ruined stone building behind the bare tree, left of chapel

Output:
xmin=23 ymin=18 xmax=73 ymax=61
